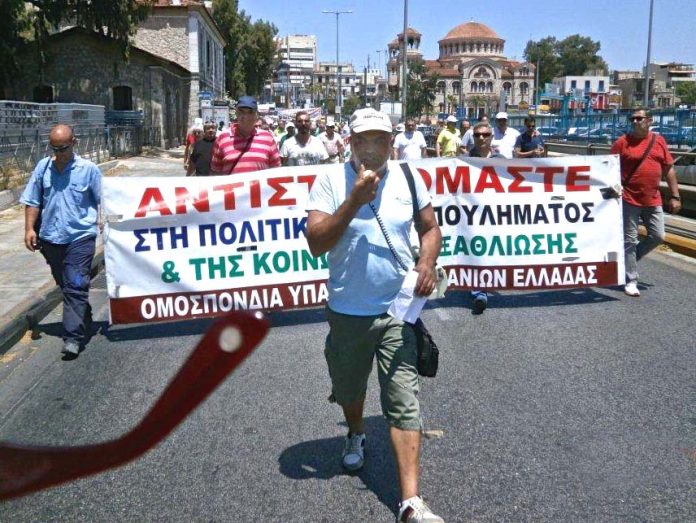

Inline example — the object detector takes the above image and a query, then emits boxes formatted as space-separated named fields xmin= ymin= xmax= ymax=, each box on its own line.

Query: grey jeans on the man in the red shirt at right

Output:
xmin=623 ymin=201 xmax=665 ymax=283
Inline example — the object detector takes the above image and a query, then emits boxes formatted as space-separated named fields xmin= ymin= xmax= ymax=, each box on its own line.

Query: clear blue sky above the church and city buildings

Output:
xmin=239 ymin=0 xmax=696 ymax=74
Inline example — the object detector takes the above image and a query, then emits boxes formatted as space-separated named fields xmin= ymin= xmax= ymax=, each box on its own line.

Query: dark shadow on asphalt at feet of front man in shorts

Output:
xmin=278 ymin=416 xmax=400 ymax=515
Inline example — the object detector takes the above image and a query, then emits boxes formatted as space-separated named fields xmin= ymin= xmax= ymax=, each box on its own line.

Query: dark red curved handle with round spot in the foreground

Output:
xmin=0 ymin=312 xmax=269 ymax=500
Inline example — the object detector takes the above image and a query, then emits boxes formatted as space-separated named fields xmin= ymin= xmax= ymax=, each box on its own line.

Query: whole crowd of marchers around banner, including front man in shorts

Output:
xmin=21 ymin=96 xmax=681 ymax=523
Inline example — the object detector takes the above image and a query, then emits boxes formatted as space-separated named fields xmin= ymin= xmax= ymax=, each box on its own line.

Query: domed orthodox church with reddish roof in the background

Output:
xmin=387 ymin=21 xmax=536 ymax=118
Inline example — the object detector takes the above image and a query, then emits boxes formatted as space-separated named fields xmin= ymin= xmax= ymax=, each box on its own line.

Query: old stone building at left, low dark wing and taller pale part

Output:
xmin=10 ymin=0 xmax=225 ymax=147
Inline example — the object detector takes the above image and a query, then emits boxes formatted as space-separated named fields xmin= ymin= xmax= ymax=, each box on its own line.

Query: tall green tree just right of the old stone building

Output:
xmin=213 ymin=0 xmax=278 ymax=98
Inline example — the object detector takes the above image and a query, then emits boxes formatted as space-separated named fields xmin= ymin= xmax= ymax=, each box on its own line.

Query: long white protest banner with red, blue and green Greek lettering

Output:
xmin=102 ymin=156 xmax=623 ymax=323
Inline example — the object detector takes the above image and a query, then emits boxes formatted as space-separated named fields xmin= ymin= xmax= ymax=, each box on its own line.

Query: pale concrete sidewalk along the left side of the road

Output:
xmin=0 ymin=148 xmax=185 ymax=355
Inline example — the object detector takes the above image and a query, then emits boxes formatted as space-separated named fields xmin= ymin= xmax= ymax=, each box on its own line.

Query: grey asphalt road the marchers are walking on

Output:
xmin=0 ymin=253 xmax=696 ymax=523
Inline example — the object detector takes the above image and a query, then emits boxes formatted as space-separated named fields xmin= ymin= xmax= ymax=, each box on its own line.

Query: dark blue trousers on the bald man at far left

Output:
xmin=41 ymin=236 xmax=96 ymax=343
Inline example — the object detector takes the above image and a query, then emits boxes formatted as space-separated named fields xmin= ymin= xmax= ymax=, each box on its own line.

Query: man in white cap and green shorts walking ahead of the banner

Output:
xmin=307 ymin=108 xmax=443 ymax=523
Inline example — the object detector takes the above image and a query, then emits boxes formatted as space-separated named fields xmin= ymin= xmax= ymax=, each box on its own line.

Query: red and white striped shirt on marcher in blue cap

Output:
xmin=210 ymin=124 xmax=280 ymax=174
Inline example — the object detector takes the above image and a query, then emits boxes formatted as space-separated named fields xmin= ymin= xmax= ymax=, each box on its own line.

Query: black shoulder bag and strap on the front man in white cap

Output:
xmin=369 ymin=163 xmax=440 ymax=378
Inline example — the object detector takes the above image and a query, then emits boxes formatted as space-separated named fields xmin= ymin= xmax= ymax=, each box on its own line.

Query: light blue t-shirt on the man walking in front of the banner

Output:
xmin=306 ymin=162 xmax=430 ymax=316
